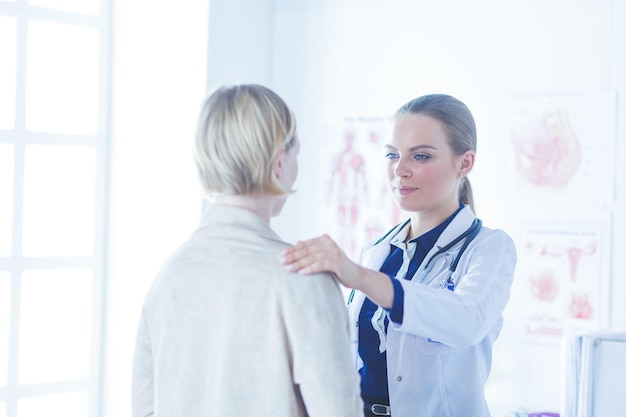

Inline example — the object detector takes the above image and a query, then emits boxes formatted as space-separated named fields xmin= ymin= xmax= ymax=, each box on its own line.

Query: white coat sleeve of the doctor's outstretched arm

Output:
xmin=390 ymin=230 xmax=517 ymax=347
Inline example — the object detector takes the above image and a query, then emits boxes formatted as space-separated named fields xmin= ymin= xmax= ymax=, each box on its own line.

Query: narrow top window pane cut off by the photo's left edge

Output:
xmin=0 ymin=16 xmax=17 ymax=129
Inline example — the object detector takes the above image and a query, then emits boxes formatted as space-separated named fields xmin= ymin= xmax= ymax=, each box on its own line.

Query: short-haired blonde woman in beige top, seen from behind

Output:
xmin=132 ymin=85 xmax=362 ymax=417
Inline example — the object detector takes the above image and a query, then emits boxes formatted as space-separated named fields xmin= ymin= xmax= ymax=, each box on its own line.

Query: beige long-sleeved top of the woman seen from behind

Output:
xmin=132 ymin=205 xmax=363 ymax=417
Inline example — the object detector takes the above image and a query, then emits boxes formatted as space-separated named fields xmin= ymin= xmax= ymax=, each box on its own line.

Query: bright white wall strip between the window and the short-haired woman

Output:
xmin=102 ymin=0 xmax=208 ymax=417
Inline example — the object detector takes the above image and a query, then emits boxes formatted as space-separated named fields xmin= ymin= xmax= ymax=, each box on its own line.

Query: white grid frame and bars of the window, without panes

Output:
xmin=0 ymin=0 xmax=112 ymax=417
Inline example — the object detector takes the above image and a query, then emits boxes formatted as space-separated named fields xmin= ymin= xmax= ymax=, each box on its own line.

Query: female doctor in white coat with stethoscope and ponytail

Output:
xmin=283 ymin=94 xmax=516 ymax=417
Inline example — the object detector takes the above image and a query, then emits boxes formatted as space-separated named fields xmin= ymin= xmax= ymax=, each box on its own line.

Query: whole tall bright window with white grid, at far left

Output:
xmin=0 ymin=0 xmax=110 ymax=417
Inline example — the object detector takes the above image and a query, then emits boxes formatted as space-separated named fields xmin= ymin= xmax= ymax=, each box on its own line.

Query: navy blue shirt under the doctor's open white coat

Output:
xmin=358 ymin=206 xmax=462 ymax=405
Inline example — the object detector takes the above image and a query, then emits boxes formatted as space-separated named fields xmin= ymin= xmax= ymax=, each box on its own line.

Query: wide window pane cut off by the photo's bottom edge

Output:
xmin=17 ymin=392 xmax=89 ymax=417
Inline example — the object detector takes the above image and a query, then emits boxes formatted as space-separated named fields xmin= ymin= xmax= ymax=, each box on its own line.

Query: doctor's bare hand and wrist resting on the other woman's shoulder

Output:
xmin=282 ymin=234 xmax=394 ymax=308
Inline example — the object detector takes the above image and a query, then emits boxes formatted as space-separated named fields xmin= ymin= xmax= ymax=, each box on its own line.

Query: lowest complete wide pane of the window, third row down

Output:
xmin=18 ymin=269 xmax=92 ymax=384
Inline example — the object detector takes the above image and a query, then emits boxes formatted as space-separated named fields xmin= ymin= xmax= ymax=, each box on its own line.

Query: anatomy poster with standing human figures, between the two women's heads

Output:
xmin=320 ymin=116 xmax=400 ymax=259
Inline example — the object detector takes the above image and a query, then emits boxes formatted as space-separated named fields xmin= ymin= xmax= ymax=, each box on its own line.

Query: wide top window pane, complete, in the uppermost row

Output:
xmin=26 ymin=21 xmax=99 ymax=135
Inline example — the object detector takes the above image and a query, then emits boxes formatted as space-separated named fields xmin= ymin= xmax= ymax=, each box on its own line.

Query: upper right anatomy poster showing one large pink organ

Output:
xmin=509 ymin=92 xmax=616 ymax=211
